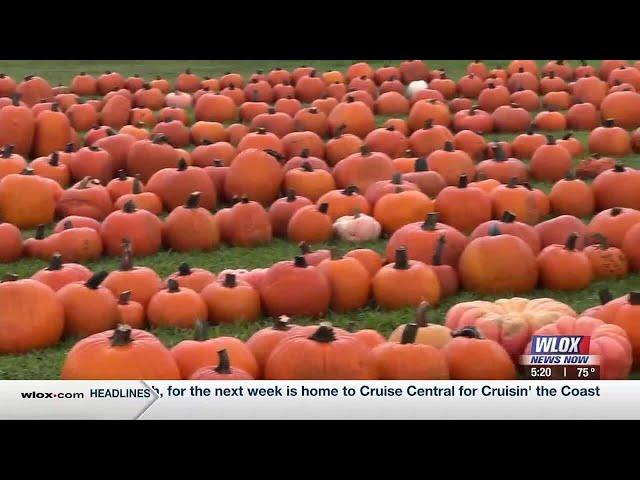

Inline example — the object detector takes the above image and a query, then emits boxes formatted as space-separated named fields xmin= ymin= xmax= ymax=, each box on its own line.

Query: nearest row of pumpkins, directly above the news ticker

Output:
xmin=61 ymin=293 xmax=640 ymax=380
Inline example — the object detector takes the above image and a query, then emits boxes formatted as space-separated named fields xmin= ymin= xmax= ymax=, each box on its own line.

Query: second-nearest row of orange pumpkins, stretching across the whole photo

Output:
xmin=0 ymin=221 xmax=640 ymax=360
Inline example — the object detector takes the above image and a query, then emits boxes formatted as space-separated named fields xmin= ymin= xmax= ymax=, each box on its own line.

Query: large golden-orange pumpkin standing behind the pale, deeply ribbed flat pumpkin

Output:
xmin=458 ymin=225 xmax=538 ymax=293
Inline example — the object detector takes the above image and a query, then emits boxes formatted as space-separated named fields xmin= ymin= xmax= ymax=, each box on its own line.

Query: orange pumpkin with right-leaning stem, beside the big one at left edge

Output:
xmin=56 ymin=271 xmax=120 ymax=337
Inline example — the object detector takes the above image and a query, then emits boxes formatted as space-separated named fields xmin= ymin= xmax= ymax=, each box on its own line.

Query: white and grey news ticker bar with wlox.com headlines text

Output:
xmin=0 ymin=380 xmax=640 ymax=420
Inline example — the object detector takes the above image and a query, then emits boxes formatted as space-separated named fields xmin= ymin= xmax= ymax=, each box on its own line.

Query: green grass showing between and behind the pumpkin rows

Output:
xmin=0 ymin=60 xmax=640 ymax=379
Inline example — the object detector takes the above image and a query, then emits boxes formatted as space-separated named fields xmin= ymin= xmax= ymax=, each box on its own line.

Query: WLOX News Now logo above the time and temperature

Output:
xmin=521 ymin=335 xmax=599 ymax=365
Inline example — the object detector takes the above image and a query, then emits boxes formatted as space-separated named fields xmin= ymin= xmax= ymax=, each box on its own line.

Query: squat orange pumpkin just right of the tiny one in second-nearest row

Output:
xmin=146 ymin=279 xmax=207 ymax=328
